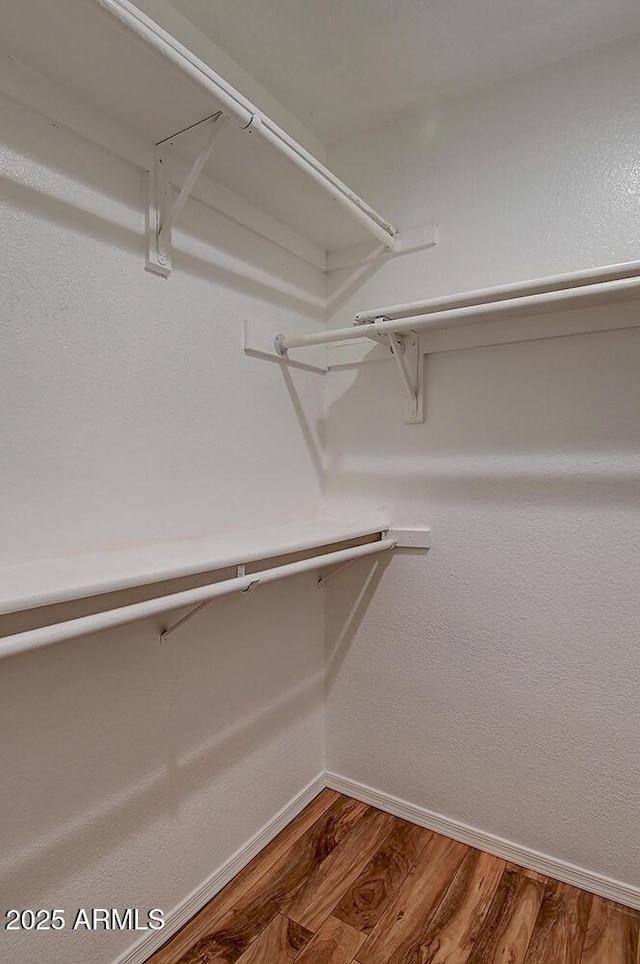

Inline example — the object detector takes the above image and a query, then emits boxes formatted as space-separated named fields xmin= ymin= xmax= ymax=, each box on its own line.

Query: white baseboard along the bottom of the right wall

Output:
xmin=325 ymin=773 xmax=640 ymax=910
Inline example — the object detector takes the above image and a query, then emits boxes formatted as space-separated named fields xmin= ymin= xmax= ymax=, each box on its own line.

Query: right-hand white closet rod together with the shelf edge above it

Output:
xmin=275 ymin=261 xmax=640 ymax=355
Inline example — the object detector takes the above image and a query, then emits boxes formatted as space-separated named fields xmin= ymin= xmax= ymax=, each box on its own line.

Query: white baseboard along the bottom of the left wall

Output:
xmin=114 ymin=773 xmax=326 ymax=964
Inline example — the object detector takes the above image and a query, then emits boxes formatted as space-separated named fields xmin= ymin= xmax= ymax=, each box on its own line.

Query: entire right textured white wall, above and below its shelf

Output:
xmin=326 ymin=39 xmax=640 ymax=886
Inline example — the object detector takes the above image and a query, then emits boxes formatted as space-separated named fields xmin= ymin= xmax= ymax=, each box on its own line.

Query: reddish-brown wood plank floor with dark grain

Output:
xmin=149 ymin=790 xmax=640 ymax=964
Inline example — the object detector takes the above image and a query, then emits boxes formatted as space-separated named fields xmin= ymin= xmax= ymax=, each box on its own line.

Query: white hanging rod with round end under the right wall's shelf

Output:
xmin=274 ymin=277 xmax=640 ymax=356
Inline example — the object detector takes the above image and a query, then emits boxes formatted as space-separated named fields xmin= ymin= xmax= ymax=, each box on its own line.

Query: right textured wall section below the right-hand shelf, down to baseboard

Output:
xmin=327 ymin=320 xmax=640 ymax=884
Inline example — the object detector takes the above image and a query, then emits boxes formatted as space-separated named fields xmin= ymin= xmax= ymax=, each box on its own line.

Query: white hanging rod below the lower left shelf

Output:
xmin=0 ymin=538 xmax=397 ymax=658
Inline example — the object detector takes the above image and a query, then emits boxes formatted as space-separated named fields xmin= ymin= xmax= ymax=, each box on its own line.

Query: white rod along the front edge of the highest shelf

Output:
xmin=91 ymin=0 xmax=398 ymax=249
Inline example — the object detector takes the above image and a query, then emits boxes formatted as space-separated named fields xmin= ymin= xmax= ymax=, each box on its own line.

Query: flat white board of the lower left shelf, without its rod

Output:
xmin=0 ymin=519 xmax=389 ymax=614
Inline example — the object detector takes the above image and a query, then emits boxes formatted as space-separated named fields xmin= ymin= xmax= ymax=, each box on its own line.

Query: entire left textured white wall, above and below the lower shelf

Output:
xmin=0 ymin=81 xmax=324 ymax=964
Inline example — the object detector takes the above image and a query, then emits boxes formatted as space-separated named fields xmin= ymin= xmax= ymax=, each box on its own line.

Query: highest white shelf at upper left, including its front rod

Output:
xmin=0 ymin=0 xmax=396 ymax=251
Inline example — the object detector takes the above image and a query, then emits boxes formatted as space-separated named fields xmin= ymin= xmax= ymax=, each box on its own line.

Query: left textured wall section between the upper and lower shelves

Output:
xmin=0 ymin=99 xmax=324 ymax=562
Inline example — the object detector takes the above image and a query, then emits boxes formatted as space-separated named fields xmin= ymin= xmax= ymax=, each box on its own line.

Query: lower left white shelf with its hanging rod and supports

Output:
xmin=0 ymin=519 xmax=440 ymax=658
